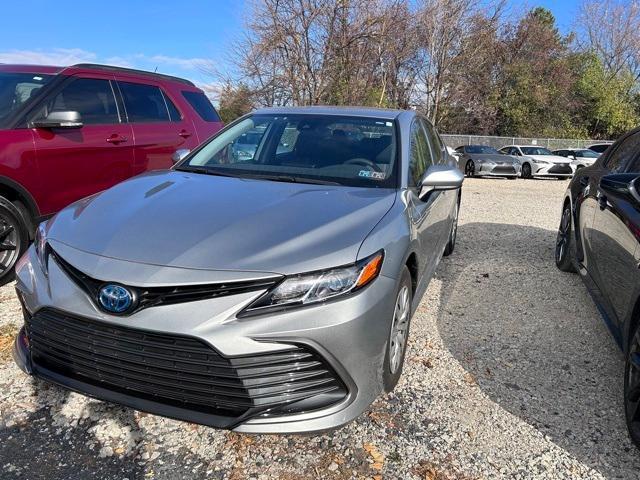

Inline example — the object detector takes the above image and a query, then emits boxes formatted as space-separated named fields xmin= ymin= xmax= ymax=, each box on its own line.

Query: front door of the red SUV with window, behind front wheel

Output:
xmin=27 ymin=75 xmax=134 ymax=214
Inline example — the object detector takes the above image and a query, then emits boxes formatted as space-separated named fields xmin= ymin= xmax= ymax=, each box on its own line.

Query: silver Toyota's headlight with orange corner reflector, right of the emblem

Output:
xmin=240 ymin=251 xmax=384 ymax=316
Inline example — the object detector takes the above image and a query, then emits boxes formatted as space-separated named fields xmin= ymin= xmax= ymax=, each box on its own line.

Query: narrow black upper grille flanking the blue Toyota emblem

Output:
xmin=48 ymin=247 xmax=279 ymax=315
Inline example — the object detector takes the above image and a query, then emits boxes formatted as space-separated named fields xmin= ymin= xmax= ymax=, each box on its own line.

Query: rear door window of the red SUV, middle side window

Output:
xmin=118 ymin=82 xmax=169 ymax=123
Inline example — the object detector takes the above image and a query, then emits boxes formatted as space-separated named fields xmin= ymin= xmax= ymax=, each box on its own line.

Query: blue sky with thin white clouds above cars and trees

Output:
xmin=0 ymin=0 xmax=580 ymax=92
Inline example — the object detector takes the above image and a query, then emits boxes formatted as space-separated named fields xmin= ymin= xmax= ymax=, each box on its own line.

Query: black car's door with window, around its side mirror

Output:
xmin=590 ymin=132 xmax=640 ymax=332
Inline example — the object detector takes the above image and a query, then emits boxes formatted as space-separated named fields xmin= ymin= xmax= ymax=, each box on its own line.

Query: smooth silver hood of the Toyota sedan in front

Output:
xmin=47 ymin=171 xmax=396 ymax=274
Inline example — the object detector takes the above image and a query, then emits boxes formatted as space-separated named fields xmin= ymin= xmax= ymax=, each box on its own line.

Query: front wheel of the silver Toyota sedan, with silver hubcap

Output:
xmin=382 ymin=266 xmax=413 ymax=392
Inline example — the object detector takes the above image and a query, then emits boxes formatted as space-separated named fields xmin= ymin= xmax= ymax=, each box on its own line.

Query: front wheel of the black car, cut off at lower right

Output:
xmin=624 ymin=322 xmax=640 ymax=448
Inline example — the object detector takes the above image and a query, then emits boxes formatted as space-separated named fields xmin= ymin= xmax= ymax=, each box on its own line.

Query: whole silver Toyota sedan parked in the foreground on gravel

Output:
xmin=14 ymin=107 xmax=463 ymax=432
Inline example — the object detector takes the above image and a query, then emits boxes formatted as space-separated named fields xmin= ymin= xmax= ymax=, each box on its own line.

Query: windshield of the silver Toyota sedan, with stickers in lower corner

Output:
xmin=176 ymin=115 xmax=396 ymax=188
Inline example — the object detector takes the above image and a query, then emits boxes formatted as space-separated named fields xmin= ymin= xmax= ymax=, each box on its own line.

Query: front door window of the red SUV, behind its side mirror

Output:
xmin=33 ymin=78 xmax=120 ymax=125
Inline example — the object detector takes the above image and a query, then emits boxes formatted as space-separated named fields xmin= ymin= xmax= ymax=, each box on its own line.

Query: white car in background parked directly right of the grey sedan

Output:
xmin=500 ymin=145 xmax=573 ymax=178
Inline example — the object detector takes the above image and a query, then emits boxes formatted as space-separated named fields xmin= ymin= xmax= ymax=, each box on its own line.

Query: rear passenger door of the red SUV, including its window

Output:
xmin=118 ymin=80 xmax=198 ymax=173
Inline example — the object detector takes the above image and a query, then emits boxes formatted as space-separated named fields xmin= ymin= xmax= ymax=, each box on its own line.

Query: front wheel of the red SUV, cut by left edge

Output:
xmin=0 ymin=197 xmax=29 ymax=285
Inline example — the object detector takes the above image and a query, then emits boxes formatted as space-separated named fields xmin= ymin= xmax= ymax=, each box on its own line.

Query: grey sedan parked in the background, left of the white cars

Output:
xmin=456 ymin=145 xmax=520 ymax=178
